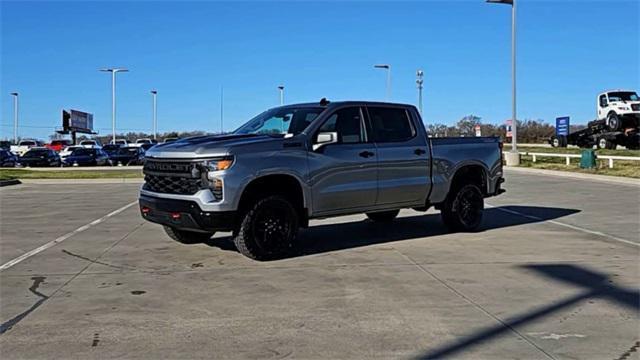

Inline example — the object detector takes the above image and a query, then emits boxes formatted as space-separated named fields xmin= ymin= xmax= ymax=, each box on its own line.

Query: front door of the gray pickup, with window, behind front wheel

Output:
xmin=308 ymin=106 xmax=378 ymax=214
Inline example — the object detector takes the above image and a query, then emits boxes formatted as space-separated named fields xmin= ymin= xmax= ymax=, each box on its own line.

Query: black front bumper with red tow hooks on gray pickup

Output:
xmin=138 ymin=195 xmax=236 ymax=232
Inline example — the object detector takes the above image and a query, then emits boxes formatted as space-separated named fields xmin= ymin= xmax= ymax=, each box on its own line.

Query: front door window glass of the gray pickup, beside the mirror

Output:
xmin=319 ymin=107 xmax=367 ymax=144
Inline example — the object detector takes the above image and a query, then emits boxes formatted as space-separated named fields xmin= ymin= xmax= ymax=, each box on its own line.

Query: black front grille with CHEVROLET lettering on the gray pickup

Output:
xmin=142 ymin=160 xmax=202 ymax=195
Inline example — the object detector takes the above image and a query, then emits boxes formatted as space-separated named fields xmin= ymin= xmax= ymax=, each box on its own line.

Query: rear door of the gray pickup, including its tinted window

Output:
xmin=367 ymin=106 xmax=431 ymax=205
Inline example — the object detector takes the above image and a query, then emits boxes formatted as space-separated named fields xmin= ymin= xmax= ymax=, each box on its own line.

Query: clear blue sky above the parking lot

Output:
xmin=0 ymin=0 xmax=640 ymax=140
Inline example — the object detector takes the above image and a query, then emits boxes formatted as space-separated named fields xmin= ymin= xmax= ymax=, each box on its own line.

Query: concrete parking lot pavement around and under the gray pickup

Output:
xmin=0 ymin=171 xmax=640 ymax=359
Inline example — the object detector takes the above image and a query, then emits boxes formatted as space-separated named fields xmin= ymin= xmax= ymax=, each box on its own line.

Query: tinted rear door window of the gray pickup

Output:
xmin=367 ymin=107 xmax=416 ymax=143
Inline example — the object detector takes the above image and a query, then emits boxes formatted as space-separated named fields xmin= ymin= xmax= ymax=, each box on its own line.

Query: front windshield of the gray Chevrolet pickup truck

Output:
xmin=233 ymin=107 xmax=324 ymax=135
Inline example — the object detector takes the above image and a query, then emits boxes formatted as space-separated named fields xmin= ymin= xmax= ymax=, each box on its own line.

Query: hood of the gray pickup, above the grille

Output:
xmin=145 ymin=134 xmax=282 ymax=158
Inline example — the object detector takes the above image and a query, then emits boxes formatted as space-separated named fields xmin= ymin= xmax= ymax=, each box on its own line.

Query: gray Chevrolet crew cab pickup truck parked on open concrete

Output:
xmin=139 ymin=99 xmax=504 ymax=260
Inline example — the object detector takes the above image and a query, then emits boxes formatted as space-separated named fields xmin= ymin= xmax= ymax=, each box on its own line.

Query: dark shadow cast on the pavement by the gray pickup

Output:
xmin=206 ymin=205 xmax=580 ymax=258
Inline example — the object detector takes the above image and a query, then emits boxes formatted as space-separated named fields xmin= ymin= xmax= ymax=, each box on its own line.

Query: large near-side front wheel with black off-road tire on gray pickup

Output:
xmin=233 ymin=195 xmax=299 ymax=261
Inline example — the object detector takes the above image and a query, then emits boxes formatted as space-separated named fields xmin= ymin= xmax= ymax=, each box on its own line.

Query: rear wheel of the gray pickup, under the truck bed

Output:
xmin=441 ymin=184 xmax=484 ymax=231
